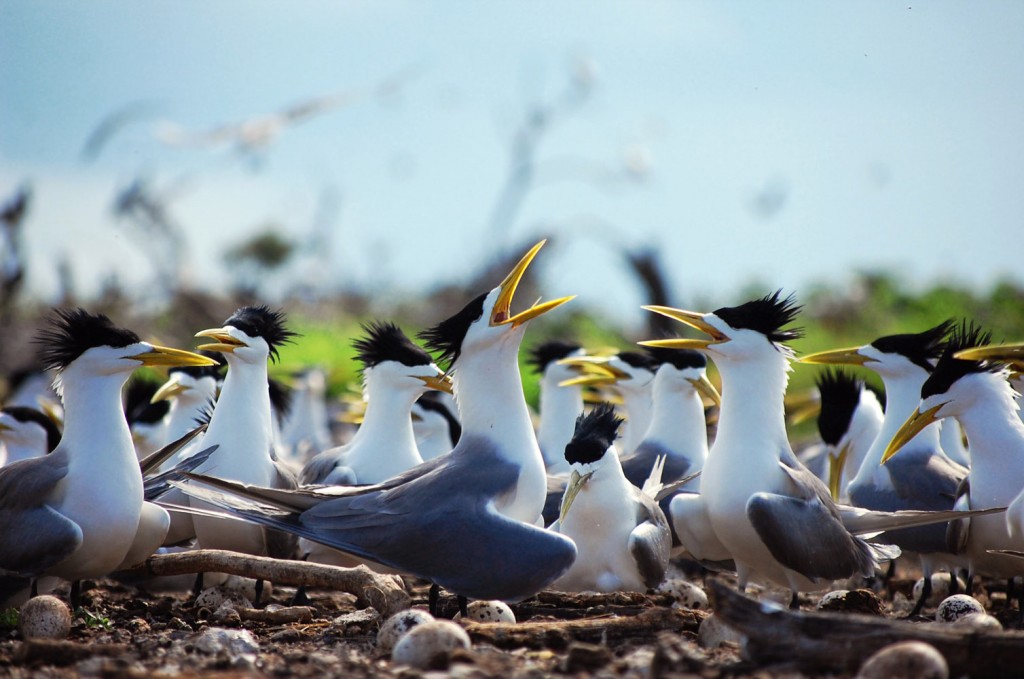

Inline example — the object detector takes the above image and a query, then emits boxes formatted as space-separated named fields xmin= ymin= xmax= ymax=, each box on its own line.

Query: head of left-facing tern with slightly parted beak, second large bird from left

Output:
xmin=196 ymin=305 xmax=296 ymax=364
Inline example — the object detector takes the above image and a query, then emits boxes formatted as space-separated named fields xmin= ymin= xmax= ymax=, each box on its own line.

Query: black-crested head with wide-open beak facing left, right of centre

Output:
xmin=641 ymin=290 xmax=803 ymax=360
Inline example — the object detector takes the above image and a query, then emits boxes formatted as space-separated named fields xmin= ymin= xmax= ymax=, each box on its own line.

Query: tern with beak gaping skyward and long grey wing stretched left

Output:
xmin=176 ymin=242 xmax=575 ymax=601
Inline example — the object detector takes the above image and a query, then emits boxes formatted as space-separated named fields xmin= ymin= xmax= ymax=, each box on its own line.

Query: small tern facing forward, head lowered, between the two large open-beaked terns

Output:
xmin=549 ymin=405 xmax=672 ymax=592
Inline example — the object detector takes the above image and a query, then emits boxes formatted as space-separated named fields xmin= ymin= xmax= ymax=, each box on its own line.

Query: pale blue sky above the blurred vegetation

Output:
xmin=0 ymin=0 xmax=1024 ymax=323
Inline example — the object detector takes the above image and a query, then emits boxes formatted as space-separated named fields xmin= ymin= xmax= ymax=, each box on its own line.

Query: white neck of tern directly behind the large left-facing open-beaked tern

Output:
xmin=644 ymin=378 xmax=708 ymax=461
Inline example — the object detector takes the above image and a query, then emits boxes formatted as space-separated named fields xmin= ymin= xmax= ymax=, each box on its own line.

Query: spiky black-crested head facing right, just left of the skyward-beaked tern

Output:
xmin=352 ymin=323 xmax=452 ymax=393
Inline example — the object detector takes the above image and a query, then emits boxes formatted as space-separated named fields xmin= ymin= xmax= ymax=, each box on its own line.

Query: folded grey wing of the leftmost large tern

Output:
xmin=0 ymin=451 xmax=82 ymax=576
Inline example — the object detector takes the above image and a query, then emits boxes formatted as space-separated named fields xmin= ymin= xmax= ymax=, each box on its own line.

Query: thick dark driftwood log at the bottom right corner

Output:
xmin=712 ymin=583 xmax=1024 ymax=679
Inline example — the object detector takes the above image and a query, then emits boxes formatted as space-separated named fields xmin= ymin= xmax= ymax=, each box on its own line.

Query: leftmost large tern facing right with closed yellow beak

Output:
xmin=0 ymin=309 xmax=210 ymax=605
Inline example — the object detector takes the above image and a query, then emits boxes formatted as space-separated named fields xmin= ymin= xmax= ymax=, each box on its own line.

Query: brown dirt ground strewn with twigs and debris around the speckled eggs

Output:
xmin=0 ymin=577 xmax=1016 ymax=679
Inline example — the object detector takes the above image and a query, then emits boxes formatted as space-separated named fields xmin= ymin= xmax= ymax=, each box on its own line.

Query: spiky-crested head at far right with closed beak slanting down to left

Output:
xmin=882 ymin=321 xmax=1006 ymax=463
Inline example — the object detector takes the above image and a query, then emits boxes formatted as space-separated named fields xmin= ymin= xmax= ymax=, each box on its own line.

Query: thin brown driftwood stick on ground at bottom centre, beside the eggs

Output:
xmin=463 ymin=608 xmax=707 ymax=650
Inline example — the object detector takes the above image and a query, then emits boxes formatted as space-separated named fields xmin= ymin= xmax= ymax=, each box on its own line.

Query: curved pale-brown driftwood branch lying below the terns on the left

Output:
xmin=117 ymin=549 xmax=412 ymax=618
